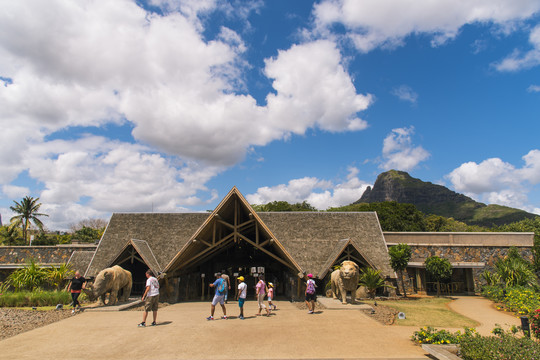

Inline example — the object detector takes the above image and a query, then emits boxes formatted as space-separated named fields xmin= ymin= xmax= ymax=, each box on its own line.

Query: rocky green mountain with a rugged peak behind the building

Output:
xmin=355 ymin=170 xmax=537 ymax=226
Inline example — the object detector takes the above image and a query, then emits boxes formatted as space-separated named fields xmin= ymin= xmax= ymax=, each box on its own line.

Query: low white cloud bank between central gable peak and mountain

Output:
xmin=246 ymin=167 xmax=371 ymax=210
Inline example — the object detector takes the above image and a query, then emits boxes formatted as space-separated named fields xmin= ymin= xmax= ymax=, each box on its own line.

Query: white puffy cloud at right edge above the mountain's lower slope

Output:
xmin=446 ymin=149 xmax=540 ymax=213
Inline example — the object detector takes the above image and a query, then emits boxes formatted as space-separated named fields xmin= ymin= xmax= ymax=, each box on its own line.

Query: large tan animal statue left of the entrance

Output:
xmin=84 ymin=265 xmax=133 ymax=305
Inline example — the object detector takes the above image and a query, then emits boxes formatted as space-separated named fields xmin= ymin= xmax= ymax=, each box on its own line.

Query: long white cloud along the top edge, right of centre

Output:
xmin=313 ymin=0 xmax=540 ymax=52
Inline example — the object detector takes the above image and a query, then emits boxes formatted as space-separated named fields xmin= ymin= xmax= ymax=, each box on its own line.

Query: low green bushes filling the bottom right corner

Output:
xmin=460 ymin=331 xmax=540 ymax=360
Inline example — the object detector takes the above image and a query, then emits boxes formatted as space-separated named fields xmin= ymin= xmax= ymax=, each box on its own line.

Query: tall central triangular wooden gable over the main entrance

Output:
xmin=165 ymin=186 xmax=302 ymax=273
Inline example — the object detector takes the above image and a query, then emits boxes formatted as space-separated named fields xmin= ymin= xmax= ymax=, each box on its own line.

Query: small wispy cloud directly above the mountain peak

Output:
xmin=380 ymin=126 xmax=430 ymax=171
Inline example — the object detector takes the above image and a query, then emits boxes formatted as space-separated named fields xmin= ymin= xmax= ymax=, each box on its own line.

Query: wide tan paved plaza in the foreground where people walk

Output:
xmin=0 ymin=301 xmax=427 ymax=360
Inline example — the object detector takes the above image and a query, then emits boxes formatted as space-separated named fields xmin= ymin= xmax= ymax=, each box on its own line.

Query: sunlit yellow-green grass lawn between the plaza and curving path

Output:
xmin=365 ymin=297 xmax=479 ymax=328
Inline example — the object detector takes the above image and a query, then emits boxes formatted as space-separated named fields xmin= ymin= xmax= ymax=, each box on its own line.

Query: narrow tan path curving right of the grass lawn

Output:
xmin=449 ymin=296 xmax=521 ymax=335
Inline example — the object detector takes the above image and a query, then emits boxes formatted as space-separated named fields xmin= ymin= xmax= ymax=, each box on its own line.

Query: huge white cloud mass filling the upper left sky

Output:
xmin=0 ymin=0 xmax=372 ymax=228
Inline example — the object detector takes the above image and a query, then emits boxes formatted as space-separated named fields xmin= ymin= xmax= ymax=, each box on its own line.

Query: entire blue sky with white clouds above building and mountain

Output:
xmin=0 ymin=0 xmax=540 ymax=230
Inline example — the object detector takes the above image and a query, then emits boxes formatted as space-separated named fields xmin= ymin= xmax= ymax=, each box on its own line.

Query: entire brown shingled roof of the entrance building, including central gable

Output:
xmin=86 ymin=188 xmax=394 ymax=277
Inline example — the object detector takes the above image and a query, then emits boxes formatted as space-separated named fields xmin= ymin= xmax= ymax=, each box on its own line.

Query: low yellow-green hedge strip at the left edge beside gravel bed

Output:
xmin=0 ymin=290 xmax=71 ymax=307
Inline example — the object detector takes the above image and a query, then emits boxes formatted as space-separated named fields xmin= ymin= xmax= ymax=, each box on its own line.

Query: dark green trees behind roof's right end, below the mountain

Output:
xmin=328 ymin=201 xmax=426 ymax=231
